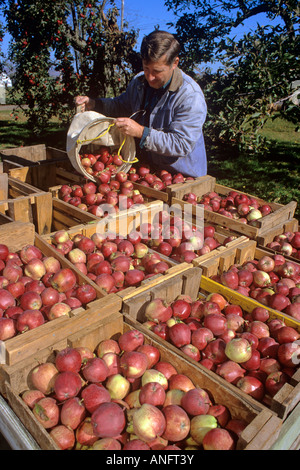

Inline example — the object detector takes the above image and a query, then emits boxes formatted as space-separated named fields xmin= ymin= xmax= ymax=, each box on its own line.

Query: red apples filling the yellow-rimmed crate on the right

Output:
xmin=143 ymin=293 xmax=300 ymax=405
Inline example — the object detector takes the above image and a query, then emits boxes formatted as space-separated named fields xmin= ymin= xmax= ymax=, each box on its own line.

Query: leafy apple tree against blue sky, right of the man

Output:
xmin=165 ymin=0 xmax=299 ymax=151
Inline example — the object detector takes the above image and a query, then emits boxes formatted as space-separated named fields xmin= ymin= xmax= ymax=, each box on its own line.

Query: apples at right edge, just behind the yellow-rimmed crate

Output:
xmin=212 ymin=253 xmax=300 ymax=320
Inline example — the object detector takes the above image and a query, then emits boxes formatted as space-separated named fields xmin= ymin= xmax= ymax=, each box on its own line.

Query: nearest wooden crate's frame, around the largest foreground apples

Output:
xmin=5 ymin=315 xmax=282 ymax=450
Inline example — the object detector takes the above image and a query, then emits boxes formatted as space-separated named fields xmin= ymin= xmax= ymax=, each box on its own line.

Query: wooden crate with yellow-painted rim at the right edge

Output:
xmin=200 ymin=276 xmax=300 ymax=419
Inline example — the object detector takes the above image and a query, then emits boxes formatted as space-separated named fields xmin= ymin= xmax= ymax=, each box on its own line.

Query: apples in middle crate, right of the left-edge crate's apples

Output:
xmin=51 ymin=230 xmax=170 ymax=294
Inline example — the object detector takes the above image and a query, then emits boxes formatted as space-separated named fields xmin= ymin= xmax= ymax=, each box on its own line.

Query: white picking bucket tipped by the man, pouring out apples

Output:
xmin=66 ymin=111 xmax=137 ymax=183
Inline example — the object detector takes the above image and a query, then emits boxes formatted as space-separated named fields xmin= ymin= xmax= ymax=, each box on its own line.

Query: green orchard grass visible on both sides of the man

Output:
xmin=0 ymin=107 xmax=300 ymax=219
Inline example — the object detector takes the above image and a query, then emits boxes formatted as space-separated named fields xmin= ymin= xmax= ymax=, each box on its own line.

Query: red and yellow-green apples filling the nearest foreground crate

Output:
xmin=21 ymin=329 xmax=247 ymax=451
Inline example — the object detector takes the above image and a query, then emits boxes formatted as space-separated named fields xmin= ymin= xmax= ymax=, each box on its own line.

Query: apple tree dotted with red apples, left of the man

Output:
xmin=0 ymin=0 xmax=138 ymax=131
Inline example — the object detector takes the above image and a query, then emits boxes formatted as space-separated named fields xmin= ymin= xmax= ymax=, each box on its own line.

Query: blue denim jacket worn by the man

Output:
xmin=95 ymin=68 xmax=207 ymax=177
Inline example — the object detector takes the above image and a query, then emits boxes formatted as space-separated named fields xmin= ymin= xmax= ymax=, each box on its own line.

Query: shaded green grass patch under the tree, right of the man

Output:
xmin=207 ymin=120 xmax=300 ymax=219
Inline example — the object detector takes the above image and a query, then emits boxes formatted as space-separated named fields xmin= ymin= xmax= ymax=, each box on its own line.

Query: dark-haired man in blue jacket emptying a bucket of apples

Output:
xmin=76 ymin=31 xmax=207 ymax=177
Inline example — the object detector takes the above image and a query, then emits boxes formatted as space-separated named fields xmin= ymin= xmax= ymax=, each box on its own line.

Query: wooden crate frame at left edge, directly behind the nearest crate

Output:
xmin=0 ymin=229 xmax=122 ymax=365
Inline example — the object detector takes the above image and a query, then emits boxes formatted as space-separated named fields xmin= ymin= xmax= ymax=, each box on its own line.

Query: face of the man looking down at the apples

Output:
xmin=143 ymin=56 xmax=179 ymax=90
